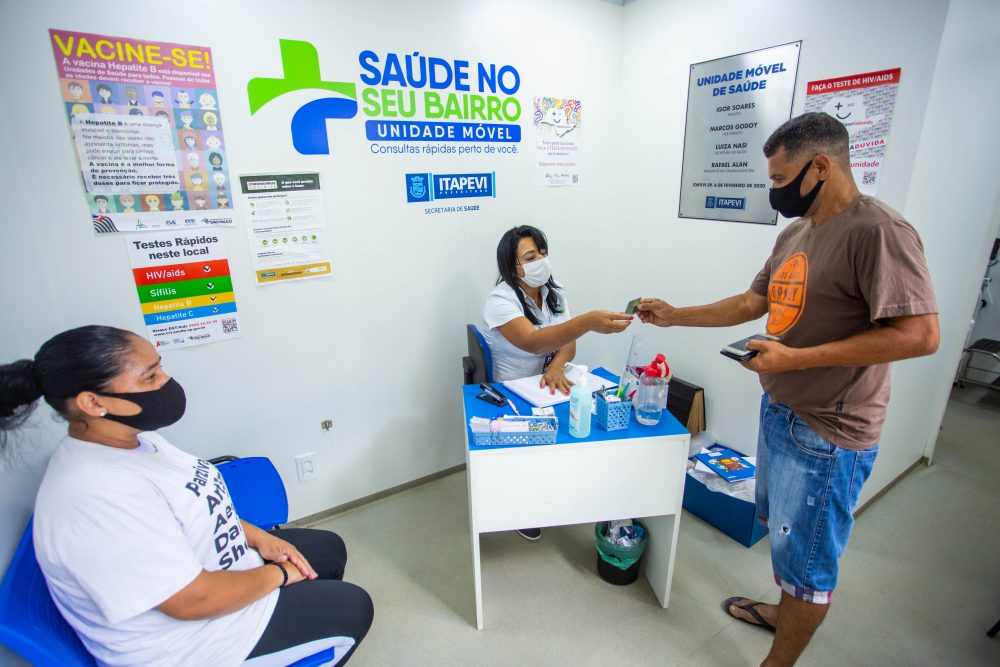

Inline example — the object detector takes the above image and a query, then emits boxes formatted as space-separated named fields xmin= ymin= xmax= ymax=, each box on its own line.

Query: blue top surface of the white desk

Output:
xmin=462 ymin=368 xmax=687 ymax=451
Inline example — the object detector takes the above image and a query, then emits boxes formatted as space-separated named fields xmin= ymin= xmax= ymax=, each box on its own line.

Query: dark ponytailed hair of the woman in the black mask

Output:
xmin=0 ymin=324 xmax=136 ymax=444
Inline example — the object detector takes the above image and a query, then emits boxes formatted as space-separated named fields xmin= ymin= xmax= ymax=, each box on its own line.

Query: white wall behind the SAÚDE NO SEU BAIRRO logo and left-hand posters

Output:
xmin=0 ymin=0 xmax=624 ymax=563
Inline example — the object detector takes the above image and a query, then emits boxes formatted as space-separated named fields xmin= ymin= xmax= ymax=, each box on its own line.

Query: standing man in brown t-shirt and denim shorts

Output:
xmin=639 ymin=113 xmax=939 ymax=665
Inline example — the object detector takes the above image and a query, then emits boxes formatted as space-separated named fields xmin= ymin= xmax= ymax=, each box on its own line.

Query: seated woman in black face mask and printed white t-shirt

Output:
xmin=0 ymin=326 xmax=373 ymax=667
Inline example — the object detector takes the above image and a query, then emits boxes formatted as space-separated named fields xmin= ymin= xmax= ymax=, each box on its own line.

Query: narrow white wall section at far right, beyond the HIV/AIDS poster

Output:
xmin=891 ymin=0 xmax=1000 ymax=468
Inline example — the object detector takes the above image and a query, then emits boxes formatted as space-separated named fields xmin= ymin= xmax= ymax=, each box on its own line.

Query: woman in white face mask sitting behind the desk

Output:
xmin=483 ymin=225 xmax=632 ymax=540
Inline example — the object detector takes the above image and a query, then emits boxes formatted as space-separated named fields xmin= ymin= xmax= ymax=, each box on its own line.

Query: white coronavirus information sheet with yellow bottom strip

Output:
xmin=240 ymin=174 xmax=330 ymax=284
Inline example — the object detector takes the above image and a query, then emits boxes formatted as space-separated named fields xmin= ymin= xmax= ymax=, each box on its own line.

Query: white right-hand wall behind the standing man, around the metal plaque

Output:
xmin=619 ymin=0 xmax=997 ymax=500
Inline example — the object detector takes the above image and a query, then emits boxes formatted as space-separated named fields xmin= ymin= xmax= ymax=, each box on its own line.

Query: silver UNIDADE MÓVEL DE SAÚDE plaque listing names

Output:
xmin=678 ymin=42 xmax=802 ymax=225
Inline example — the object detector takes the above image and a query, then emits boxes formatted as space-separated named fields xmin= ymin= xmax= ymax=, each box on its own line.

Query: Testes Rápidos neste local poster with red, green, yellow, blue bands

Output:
xmin=125 ymin=230 xmax=240 ymax=348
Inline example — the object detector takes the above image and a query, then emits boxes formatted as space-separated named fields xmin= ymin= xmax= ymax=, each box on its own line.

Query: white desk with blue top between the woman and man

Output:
xmin=462 ymin=369 xmax=690 ymax=630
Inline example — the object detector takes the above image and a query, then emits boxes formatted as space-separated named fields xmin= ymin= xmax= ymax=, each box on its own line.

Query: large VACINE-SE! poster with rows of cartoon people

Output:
xmin=49 ymin=30 xmax=234 ymax=233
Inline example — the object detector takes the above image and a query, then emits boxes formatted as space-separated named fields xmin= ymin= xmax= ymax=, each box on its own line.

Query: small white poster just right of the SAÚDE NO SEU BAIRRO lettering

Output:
xmin=532 ymin=97 xmax=583 ymax=186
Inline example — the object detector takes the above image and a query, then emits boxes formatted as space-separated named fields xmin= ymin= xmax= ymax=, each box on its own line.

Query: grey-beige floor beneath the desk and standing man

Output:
xmin=312 ymin=389 xmax=1000 ymax=666
